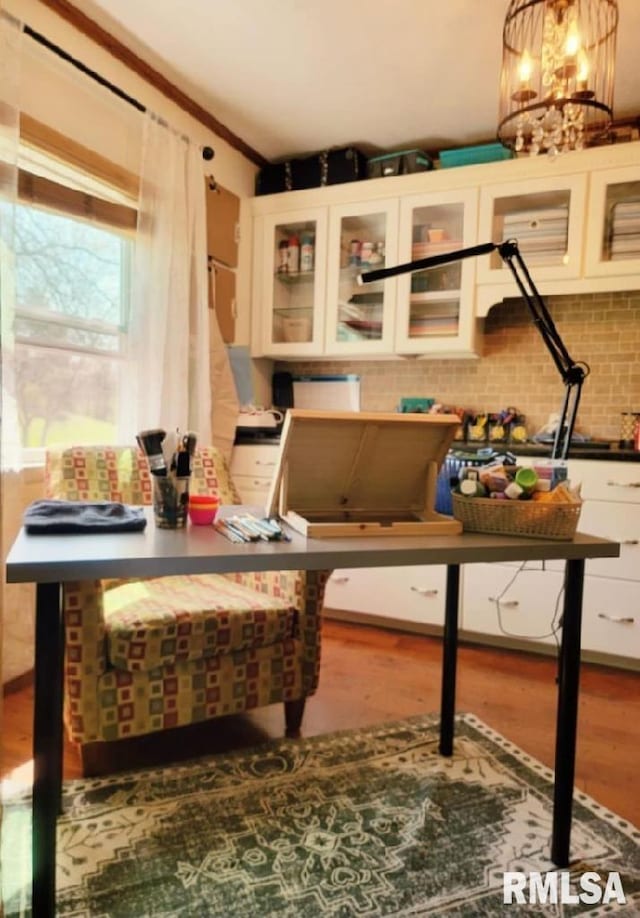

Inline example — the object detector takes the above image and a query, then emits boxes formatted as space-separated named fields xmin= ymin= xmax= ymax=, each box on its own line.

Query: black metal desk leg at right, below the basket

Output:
xmin=551 ymin=559 xmax=584 ymax=867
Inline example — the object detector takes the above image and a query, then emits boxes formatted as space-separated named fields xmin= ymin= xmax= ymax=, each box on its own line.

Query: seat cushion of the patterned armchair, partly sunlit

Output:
xmin=104 ymin=574 xmax=296 ymax=672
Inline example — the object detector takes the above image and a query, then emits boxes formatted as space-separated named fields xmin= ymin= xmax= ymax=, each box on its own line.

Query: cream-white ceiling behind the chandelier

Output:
xmin=78 ymin=0 xmax=640 ymax=160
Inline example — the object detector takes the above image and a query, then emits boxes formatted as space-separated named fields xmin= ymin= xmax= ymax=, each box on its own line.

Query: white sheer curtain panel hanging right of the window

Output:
xmin=122 ymin=114 xmax=211 ymax=443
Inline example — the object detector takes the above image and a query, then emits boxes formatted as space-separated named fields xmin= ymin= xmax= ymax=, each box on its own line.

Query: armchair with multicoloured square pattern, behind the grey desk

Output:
xmin=45 ymin=447 xmax=328 ymax=773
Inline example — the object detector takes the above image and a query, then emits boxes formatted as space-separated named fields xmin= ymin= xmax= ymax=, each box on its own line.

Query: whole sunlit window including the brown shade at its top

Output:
xmin=14 ymin=126 xmax=136 ymax=462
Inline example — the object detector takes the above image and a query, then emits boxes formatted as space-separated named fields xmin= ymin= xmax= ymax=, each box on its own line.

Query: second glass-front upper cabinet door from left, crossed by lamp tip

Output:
xmin=325 ymin=199 xmax=398 ymax=355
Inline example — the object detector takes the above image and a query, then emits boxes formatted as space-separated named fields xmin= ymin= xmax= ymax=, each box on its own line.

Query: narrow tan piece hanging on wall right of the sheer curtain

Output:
xmin=209 ymin=272 xmax=240 ymax=462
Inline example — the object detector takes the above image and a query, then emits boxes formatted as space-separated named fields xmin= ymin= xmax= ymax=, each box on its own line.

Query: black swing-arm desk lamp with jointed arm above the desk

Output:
xmin=358 ymin=239 xmax=589 ymax=459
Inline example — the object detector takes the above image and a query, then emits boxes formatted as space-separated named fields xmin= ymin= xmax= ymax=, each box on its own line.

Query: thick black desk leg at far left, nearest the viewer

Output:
xmin=32 ymin=583 xmax=64 ymax=918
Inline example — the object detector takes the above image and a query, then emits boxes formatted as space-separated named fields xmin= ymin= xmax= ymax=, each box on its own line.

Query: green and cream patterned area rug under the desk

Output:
xmin=2 ymin=715 xmax=640 ymax=918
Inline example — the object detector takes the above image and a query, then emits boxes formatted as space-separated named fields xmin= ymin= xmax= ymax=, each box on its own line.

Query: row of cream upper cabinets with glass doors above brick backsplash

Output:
xmin=252 ymin=142 xmax=640 ymax=359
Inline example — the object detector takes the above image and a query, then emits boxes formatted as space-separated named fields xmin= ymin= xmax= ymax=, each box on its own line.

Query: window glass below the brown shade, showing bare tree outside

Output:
xmin=15 ymin=205 xmax=131 ymax=448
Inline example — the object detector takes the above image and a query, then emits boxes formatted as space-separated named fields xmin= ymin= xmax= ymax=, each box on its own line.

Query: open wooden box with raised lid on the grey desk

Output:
xmin=267 ymin=408 xmax=462 ymax=537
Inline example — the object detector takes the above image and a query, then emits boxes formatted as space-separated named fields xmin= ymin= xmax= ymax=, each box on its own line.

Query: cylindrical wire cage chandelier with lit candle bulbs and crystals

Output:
xmin=498 ymin=0 xmax=618 ymax=156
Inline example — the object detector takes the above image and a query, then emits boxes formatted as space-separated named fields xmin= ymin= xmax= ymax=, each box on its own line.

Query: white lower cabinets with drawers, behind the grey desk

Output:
xmin=231 ymin=443 xmax=640 ymax=669
